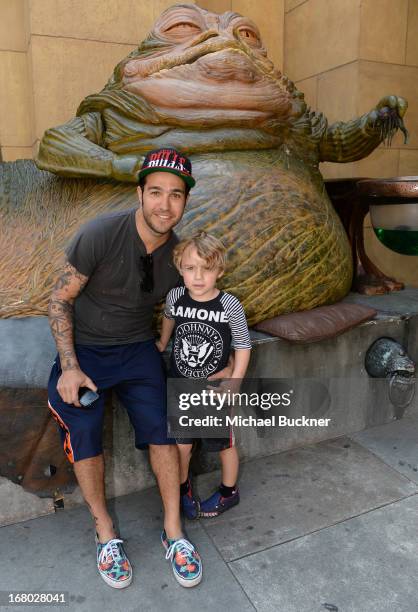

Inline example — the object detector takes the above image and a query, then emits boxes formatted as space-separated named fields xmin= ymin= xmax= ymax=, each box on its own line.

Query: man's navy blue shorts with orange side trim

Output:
xmin=48 ymin=340 xmax=175 ymax=463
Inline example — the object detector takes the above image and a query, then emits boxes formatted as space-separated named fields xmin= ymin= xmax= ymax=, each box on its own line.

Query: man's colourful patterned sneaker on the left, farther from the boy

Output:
xmin=96 ymin=536 xmax=132 ymax=589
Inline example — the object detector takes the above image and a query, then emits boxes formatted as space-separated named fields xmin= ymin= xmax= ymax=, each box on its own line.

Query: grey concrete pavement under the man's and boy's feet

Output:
xmin=0 ymin=415 xmax=418 ymax=612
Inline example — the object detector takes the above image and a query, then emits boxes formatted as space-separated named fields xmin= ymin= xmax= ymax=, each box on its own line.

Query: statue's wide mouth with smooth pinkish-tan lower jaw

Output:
xmin=124 ymin=41 xmax=291 ymax=120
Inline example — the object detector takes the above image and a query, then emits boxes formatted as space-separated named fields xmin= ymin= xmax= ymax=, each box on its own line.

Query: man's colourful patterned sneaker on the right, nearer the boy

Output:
xmin=161 ymin=530 xmax=202 ymax=587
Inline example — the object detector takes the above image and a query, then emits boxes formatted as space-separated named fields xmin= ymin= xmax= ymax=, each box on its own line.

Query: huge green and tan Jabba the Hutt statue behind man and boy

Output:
xmin=0 ymin=5 xmax=407 ymax=324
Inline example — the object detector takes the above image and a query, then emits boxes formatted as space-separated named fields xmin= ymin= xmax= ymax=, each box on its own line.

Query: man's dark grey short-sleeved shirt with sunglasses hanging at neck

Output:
xmin=66 ymin=209 xmax=180 ymax=345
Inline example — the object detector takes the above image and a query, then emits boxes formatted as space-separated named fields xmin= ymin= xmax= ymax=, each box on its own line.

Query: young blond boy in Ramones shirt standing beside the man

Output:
xmin=157 ymin=232 xmax=251 ymax=519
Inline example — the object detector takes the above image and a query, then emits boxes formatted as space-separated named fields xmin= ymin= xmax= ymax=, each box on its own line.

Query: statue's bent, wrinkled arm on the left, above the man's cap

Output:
xmin=35 ymin=113 xmax=139 ymax=181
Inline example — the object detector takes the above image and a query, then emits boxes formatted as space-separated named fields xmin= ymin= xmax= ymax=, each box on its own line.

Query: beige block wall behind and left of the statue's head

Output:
xmin=0 ymin=0 xmax=284 ymax=161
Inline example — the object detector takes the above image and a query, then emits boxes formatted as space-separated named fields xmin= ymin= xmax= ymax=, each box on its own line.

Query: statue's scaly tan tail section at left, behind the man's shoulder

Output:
xmin=0 ymin=160 xmax=137 ymax=318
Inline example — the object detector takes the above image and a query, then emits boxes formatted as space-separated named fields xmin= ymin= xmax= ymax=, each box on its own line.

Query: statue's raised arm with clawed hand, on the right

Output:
xmin=319 ymin=96 xmax=408 ymax=163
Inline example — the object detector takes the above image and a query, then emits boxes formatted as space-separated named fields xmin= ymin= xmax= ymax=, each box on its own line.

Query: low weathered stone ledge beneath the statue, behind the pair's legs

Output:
xmin=0 ymin=310 xmax=418 ymax=527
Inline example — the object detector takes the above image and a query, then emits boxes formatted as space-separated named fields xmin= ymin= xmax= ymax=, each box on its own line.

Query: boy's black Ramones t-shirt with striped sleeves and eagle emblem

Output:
xmin=164 ymin=287 xmax=251 ymax=378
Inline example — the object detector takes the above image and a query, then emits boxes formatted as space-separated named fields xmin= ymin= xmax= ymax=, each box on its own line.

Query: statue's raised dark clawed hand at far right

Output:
xmin=366 ymin=96 xmax=408 ymax=145
